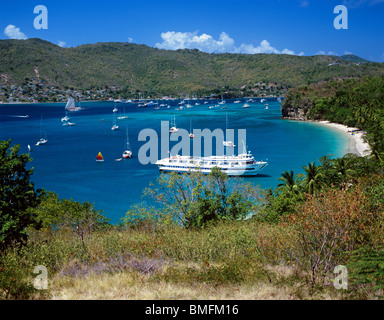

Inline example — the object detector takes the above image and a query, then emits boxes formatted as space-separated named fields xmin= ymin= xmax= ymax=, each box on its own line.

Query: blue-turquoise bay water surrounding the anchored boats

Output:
xmin=0 ymin=99 xmax=348 ymax=223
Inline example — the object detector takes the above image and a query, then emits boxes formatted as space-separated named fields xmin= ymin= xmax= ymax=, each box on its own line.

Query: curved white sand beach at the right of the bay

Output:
xmin=313 ymin=121 xmax=371 ymax=156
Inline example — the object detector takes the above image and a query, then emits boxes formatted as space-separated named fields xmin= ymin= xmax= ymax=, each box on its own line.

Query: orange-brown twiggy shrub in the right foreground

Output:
xmin=287 ymin=186 xmax=377 ymax=284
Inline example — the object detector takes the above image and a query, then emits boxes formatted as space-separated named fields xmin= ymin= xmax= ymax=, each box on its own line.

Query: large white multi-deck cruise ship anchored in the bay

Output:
xmin=156 ymin=152 xmax=268 ymax=176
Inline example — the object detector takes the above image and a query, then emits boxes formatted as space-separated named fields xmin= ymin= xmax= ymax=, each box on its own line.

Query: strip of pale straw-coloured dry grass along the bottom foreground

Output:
xmin=48 ymin=272 xmax=292 ymax=300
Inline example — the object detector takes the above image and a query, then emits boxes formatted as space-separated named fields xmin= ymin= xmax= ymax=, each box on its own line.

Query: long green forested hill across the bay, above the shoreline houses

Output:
xmin=0 ymin=38 xmax=384 ymax=94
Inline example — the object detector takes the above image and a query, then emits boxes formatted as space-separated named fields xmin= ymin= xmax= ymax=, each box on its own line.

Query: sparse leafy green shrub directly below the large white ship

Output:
xmin=122 ymin=168 xmax=259 ymax=229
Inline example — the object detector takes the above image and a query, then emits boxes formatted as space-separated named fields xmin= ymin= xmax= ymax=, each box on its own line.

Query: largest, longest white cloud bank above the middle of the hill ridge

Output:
xmin=155 ymin=31 xmax=304 ymax=55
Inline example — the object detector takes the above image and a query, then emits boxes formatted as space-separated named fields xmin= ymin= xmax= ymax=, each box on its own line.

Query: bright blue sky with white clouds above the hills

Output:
xmin=0 ymin=0 xmax=384 ymax=62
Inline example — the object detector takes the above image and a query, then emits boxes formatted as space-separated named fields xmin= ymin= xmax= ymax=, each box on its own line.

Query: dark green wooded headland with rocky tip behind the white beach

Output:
xmin=282 ymin=77 xmax=384 ymax=160
